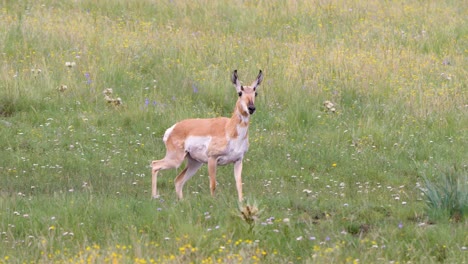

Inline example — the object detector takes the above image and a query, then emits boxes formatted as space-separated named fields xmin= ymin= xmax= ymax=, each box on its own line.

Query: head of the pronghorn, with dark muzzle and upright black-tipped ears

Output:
xmin=231 ymin=70 xmax=263 ymax=116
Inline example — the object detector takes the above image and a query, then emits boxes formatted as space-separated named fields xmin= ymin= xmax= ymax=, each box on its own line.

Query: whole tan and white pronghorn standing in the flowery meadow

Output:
xmin=151 ymin=70 xmax=263 ymax=201
